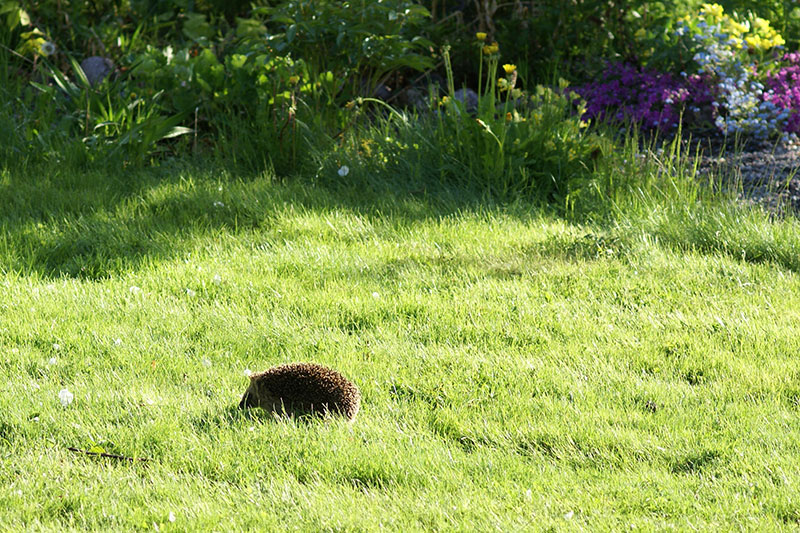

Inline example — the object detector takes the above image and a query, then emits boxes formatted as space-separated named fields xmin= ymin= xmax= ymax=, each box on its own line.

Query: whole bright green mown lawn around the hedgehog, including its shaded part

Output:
xmin=0 ymin=167 xmax=800 ymax=531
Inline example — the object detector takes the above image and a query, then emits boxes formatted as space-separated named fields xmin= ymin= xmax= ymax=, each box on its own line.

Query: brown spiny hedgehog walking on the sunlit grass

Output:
xmin=239 ymin=363 xmax=361 ymax=422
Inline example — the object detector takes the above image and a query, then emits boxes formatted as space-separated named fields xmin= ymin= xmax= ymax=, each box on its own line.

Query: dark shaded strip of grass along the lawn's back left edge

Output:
xmin=0 ymin=158 xmax=520 ymax=279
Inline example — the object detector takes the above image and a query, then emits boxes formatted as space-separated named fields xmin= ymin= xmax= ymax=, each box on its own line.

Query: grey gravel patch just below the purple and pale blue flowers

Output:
xmin=690 ymin=139 xmax=800 ymax=216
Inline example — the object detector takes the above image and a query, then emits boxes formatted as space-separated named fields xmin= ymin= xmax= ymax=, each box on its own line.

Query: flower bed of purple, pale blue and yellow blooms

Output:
xmin=575 ymin=4 xmax=800 ymax=139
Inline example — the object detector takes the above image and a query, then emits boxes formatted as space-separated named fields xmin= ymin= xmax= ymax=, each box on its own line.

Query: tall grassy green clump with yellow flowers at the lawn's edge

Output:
xmin=314 ymin=40 xmax=613 ymax=211
